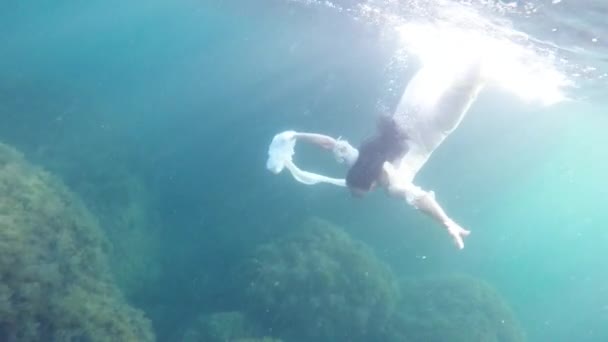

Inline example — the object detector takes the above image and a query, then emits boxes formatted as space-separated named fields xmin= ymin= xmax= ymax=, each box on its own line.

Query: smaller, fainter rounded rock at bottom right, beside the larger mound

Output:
xmin=387 ymin=275 xmax=525 ymax=342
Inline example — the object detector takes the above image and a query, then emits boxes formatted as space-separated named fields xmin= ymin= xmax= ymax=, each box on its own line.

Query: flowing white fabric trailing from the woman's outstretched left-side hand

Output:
xmin=266 ymin=131 xmax=346 ymax=187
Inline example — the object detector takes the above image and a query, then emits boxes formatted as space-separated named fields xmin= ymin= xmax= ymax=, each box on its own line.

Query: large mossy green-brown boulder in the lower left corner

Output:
xmin=0 ymin=144 xmax=154 ymax=341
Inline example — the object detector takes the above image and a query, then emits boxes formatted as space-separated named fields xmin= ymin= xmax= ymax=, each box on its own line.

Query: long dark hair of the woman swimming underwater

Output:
xmin=346 ymin=116 xmax=407 ymax=191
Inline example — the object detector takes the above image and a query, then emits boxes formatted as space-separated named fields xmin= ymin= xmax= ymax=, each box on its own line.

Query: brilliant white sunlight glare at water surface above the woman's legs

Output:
xmin=397 ymin=23 xmax=572 ymax=105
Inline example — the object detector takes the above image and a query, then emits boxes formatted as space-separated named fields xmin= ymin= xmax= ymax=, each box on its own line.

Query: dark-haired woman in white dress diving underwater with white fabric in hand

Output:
xmin=267 ymin=59 xmax=485 ymax=249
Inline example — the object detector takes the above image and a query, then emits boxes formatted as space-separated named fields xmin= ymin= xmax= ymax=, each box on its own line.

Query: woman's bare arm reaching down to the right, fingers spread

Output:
xmin=384 ymin=163 xmax=470 ymax=249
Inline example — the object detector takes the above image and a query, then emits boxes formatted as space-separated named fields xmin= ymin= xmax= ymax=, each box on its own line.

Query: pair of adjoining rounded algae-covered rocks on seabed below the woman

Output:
xmin=235 ymin=219 xmax=524 ymax=342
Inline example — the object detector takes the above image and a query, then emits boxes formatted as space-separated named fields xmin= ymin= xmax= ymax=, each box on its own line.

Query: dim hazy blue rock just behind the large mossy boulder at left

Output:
xmin=36 ymin=140 xmax=162 ymax=302
